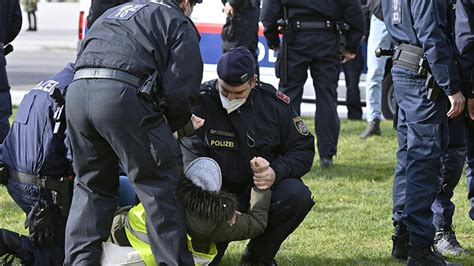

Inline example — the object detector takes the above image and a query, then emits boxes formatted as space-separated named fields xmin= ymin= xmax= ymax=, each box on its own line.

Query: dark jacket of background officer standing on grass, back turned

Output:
xmin=261 ymin=0 xmax=364 ymax=53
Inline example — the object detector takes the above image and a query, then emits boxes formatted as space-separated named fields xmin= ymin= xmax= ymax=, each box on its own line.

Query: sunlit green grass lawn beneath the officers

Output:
xmin=0 ymin=115 xmax=474 ymax=265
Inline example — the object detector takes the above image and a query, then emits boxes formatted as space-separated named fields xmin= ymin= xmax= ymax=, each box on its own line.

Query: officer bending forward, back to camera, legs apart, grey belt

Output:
xmin=65 ymin=0 xmax=203 ymax=265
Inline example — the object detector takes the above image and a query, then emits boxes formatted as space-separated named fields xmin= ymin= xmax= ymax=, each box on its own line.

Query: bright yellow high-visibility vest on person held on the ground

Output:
xmin=125 ymin=203 xmax=217 ymax=266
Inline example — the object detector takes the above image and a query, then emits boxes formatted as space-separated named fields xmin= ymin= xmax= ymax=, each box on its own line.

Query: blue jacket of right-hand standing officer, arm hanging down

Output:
xmin=382 ymin=0 xmax=461 ymax=95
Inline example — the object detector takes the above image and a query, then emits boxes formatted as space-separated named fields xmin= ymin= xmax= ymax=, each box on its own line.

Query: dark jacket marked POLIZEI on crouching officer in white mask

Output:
xmin=181 ymin=80 xmax=314 ymax=193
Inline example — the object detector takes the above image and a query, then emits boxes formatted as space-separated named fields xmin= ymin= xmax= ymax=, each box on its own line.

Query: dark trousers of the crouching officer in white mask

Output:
xmin=212 ymin=178 xmax=314 ymax=265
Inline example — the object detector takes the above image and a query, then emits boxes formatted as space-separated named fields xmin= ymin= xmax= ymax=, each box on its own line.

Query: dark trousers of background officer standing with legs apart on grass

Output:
xmin=275 ymin=31 xmax=341 ymax=158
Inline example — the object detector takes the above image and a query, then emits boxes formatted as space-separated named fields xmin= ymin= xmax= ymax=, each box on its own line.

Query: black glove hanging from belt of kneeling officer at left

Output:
xmin=25 ymin=199 xmax=54 ymax=247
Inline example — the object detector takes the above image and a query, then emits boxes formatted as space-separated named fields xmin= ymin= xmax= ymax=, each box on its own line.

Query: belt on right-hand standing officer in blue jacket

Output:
xmin=393 ymin=44 xmax=429 ymax=76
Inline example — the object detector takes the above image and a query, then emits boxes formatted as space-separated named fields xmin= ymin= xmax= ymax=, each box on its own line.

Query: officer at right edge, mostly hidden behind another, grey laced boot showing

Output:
xmin=432 ymin=1 xmax=474 ymax=255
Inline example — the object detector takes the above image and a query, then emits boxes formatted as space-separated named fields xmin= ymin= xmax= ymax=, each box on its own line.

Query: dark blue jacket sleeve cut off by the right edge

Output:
xmin=455 ymin=0 xmax=474 ymax=98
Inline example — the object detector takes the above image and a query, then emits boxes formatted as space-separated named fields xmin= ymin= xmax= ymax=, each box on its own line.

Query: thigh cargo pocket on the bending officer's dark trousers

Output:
xmin=140 ymin=114 xmax=178 ymax=166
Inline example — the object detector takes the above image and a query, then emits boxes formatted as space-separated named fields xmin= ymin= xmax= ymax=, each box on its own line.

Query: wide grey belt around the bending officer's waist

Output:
xmin=74 ymin=68 xmax=141 ymax=88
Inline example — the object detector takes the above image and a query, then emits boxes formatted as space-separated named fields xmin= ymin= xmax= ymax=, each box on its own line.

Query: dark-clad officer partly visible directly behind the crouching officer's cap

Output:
xmin=222 ymin=0 xmax=260 ymax=76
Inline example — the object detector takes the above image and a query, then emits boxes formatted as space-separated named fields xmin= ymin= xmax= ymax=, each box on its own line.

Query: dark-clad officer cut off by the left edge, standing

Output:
xmin=0 ymin=0 xmax=22 ymax=143
